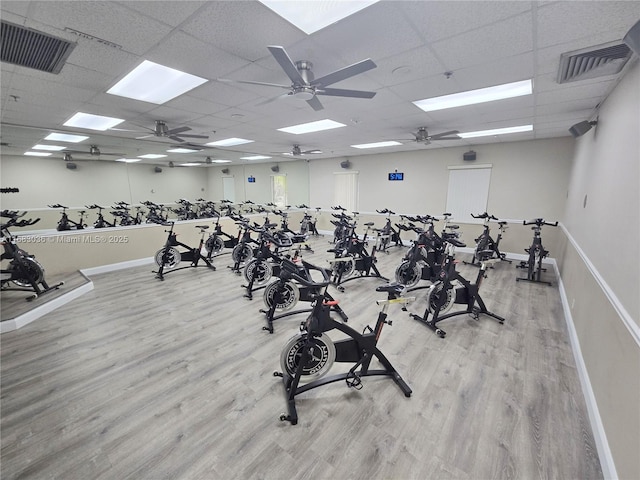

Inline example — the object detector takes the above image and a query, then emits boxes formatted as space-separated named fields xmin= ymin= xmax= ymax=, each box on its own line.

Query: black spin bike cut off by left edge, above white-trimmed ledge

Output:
xmin=0 ymin=210 xmax=64 ymax=301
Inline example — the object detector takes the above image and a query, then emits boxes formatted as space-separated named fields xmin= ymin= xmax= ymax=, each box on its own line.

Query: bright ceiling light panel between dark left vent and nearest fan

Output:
xmin=107 ymin=60 xmax=207 ymax=105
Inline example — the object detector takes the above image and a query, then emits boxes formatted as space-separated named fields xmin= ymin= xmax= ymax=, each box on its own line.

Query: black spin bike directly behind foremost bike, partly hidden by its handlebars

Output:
xmin=260 ymin=258 xmax=348 ymax=333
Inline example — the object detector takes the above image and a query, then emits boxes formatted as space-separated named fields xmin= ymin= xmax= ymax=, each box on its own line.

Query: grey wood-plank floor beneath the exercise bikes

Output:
xmin=0 ymin=238 xmax=602 ymax=480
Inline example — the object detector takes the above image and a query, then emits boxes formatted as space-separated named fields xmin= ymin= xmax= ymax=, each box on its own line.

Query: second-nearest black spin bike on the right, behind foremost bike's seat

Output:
xmin=411 ymin=238 xmax=504 ymax=338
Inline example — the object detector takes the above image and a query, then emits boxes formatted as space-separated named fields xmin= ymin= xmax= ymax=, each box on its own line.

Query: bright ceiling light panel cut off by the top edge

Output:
xmin=260 ymin=0 xmax=378 ymax=35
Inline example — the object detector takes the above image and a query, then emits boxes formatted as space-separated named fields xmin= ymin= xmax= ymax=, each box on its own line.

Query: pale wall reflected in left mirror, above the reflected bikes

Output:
xmin=0 ymin=155 xmax=309 ymax=230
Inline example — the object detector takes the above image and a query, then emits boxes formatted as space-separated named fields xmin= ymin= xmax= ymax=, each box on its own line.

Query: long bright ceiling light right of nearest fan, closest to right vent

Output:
xmin=413 ymin=80 xmax=533 ymax=112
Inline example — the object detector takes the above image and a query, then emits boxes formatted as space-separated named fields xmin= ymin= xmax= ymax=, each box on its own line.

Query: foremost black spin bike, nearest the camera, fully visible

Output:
xmin=273 ymin=270 xmax=414 ymax=425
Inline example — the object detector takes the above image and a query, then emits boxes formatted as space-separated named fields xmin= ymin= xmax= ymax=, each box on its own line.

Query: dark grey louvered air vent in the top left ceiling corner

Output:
xmin=1 ymin=22 xmax=76 ymax=74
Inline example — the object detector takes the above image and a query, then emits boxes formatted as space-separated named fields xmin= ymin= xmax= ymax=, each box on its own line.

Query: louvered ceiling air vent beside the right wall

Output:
xmin=558 ymin=42 xmax=631 ymax=83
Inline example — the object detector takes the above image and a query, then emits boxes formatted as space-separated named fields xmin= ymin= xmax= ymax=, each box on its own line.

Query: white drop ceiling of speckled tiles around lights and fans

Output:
xmin=0 ymin=0 xmax=640 ymax=165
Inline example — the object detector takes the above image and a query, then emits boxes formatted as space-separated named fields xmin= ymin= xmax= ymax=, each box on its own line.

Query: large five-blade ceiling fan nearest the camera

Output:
xmin=218 ymin=46 xmax=377 ymax=111
